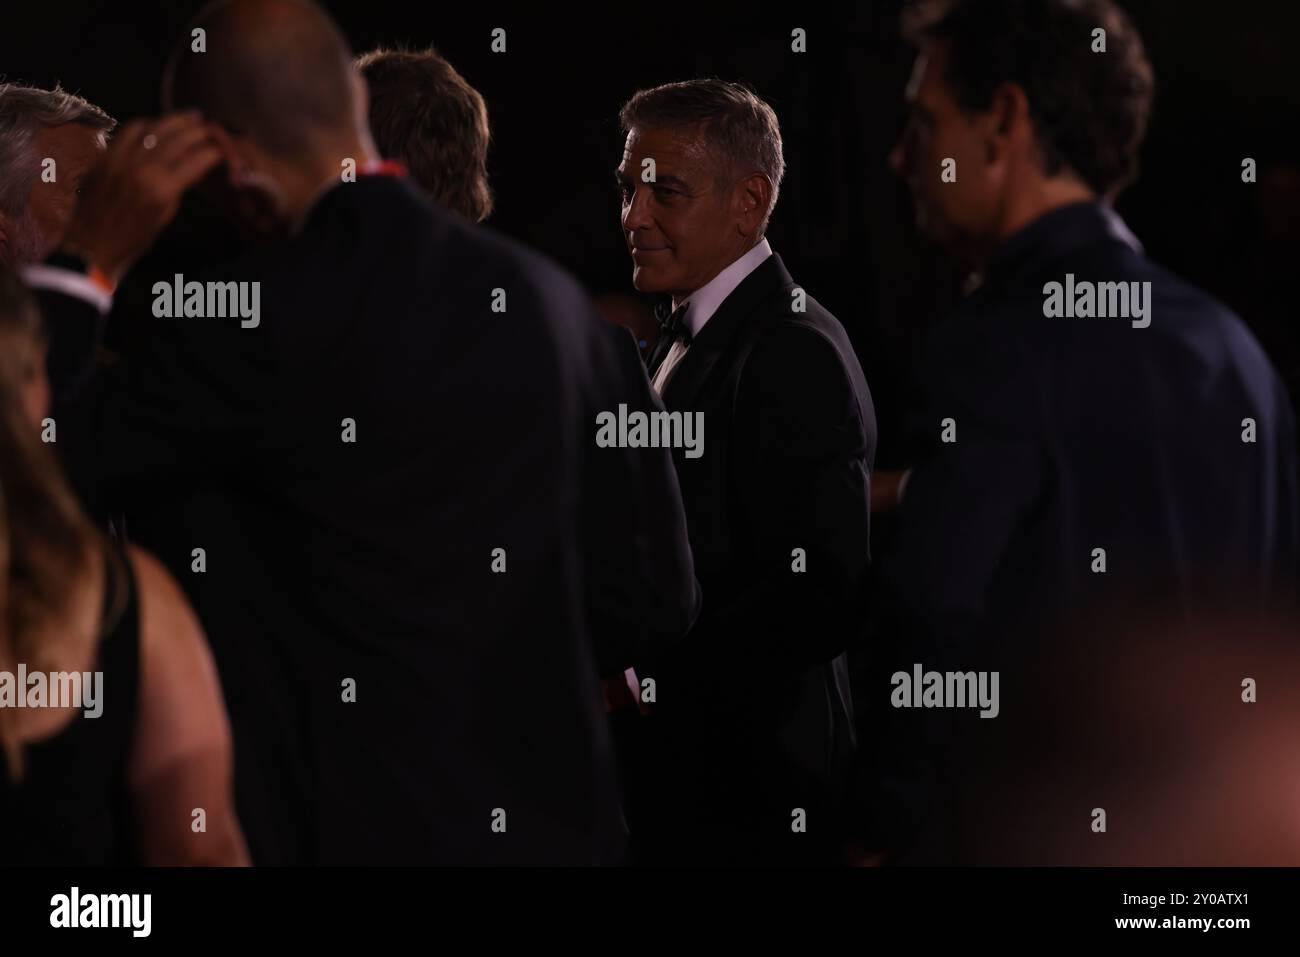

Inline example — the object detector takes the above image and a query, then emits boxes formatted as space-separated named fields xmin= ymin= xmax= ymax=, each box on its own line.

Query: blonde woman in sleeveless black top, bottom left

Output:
xmin=0 ymin=267 xmax=248 ymax=866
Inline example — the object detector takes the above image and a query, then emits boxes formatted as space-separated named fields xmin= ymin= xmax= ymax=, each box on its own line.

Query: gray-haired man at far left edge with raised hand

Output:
xmin=0 ymin=83 xmax=220 ymax=410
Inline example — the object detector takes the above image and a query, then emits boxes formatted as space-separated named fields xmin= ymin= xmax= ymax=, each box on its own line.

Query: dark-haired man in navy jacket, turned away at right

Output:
xmin=878 ymin=0 xmax=1297 ymax=863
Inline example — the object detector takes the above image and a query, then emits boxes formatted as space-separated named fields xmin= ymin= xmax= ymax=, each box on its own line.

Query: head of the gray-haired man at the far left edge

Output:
xmin=0 ymin=83 xmax=117 ymax=265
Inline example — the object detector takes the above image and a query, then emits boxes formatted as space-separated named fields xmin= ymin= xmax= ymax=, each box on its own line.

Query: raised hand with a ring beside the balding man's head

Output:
xmin=64 ymin=111 xmax=221 ymax=282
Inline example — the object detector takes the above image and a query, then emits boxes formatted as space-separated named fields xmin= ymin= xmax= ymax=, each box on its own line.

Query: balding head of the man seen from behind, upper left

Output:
xmin=163 ymin=0 xmax=364 ymax=160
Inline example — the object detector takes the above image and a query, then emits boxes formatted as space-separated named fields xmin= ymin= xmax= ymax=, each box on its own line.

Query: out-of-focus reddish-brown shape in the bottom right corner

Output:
xmin=952 ymin=609 xmax=1300 ymax=867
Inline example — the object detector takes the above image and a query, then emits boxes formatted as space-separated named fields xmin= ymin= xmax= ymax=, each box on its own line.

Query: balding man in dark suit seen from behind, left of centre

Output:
xmin=30 ymin=0 xmax=698 ymax=863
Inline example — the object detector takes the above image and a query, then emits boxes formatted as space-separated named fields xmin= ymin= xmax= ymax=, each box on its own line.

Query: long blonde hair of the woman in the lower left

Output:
xmin=0 ymin=267 xmax=109 ymax=780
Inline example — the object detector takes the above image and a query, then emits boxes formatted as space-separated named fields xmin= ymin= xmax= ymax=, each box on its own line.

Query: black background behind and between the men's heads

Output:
xmin=0 ymin=0 xmax=1300 ymax=467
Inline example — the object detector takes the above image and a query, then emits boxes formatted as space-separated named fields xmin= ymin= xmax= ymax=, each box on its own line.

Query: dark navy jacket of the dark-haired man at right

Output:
xmin=889 ymin=203 xmax=1296 ymax=657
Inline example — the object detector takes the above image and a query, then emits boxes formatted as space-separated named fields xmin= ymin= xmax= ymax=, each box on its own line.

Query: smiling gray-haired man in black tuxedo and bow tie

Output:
xmin=618 ymin=81 xmax=876 ymax=863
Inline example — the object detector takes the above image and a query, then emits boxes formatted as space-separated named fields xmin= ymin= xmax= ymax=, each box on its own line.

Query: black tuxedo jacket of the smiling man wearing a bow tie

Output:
xmin=633 ymin=255 xmax=876 ymax=862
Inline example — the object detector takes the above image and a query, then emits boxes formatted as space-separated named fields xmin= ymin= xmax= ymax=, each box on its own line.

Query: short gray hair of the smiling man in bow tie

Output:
xmin=619 ymin=79 xmax=785 ymax=235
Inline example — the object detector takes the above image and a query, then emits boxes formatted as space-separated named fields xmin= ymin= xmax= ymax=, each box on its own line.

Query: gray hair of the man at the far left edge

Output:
xmin=0 ymin=83 xmax=117 ymax=217
